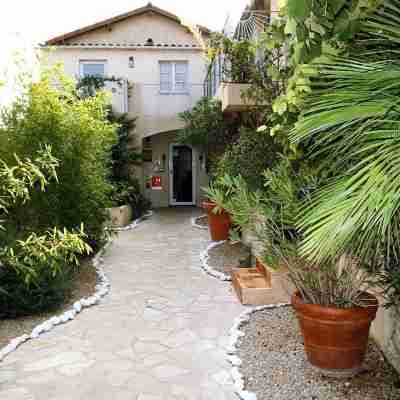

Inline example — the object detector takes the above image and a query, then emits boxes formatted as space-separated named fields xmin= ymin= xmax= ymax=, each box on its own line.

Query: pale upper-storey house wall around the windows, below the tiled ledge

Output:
xmin=44 ymin=48 xmax=206 ymax=142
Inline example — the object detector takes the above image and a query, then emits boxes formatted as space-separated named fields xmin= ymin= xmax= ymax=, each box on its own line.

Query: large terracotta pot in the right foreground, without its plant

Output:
xmin=292 ymin=292 xmax=378 ymax=378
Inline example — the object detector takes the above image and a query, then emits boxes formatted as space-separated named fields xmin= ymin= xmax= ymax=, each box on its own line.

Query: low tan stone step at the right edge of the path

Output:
xmin=232 ymin=268 xmax=289 ymax=306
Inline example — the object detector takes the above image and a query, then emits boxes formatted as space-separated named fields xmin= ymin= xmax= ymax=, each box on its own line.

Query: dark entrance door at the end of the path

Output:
xmin=171 ymin=145 xmax=194 ymax=205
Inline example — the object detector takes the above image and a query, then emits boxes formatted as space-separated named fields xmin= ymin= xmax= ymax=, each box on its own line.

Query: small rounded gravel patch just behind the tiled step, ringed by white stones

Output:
xmin=208 ymin=242 xmax=251 ymax=274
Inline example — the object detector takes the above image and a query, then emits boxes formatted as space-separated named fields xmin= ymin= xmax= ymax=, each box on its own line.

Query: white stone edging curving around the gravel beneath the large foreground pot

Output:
xmin=227 ymin=303 xmax=290 ymax=400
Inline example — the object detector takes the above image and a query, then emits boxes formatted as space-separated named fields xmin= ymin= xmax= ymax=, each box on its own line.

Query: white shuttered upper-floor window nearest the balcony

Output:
xmin=160 ymin=61 xmax=188 ymax=93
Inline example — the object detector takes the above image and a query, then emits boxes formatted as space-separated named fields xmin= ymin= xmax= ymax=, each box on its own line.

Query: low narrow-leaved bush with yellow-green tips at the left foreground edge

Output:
xmin=0 ymin=147 xmax=91 ymax=318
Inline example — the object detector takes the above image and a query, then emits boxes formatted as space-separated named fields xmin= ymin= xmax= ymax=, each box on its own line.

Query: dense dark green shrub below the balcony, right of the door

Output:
xmin=214 ymin=128 xmax=280 ymax=189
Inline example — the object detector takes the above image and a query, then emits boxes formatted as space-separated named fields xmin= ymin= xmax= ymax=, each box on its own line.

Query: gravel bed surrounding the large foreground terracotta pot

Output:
xmin=238 ymin=307 xmax=400 ymax=400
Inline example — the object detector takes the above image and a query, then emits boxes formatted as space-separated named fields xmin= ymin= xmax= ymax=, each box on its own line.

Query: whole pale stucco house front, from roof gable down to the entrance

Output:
xmin=42 ymin=13 xmax=207 ymax=207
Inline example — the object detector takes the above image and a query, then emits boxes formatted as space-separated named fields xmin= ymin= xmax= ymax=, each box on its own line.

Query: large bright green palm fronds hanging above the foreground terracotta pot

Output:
xmin=293 ymin=60 xmax=400 ymax=261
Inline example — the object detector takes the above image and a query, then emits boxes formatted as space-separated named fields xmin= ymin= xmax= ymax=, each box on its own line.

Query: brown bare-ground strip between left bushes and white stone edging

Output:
xmin=0 ymin=261 xmax=97 ymax=348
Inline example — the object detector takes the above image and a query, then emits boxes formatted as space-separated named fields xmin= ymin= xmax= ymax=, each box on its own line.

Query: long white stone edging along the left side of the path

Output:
xmin=0 ymin=212 xmax=152 ymax=363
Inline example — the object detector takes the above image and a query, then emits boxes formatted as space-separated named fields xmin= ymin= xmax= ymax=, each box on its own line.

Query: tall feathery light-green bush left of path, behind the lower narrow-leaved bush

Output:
xmin=0 ymin=68 xmax=116 ymax=242
